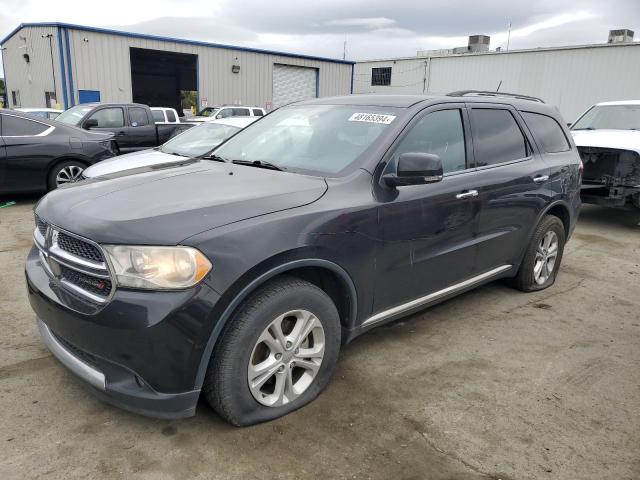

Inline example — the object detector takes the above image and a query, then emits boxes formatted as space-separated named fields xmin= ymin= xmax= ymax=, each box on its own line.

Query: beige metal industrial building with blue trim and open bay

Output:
xmin=0 ymin=23 xmax=353 ymax=113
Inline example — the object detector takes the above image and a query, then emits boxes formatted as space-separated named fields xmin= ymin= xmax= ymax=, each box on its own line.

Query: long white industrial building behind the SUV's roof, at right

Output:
xmin=353 ymin=30 xmax=640 ymax=121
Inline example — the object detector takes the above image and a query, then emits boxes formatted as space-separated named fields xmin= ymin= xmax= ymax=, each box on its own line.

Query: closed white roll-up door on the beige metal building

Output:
xmin=273 ymin=63 xmax=318 ymax=108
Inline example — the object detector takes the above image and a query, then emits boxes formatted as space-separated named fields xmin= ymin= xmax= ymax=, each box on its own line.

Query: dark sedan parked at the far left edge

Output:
xmin=0 ymin=109 xmax=116 ymax=195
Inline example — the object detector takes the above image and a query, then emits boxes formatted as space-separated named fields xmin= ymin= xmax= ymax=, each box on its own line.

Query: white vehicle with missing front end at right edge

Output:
xmin=571 ymin=100 xmax=640 ymax=208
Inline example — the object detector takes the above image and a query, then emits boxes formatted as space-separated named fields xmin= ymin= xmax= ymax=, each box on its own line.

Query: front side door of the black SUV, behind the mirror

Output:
xmin=373 ymin=104 xmax=479 ymax=315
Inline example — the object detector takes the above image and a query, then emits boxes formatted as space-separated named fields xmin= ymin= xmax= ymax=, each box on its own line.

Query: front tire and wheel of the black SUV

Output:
xmin=203 ymin=276 xmax=341 ymax=426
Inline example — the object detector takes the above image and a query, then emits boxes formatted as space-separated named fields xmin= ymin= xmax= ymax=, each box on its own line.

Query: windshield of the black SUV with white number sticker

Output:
xmin=215 ymin=105 xmax=399 ymax=175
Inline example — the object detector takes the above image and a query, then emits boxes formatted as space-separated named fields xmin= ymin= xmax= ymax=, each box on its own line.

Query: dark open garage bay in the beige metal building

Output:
xmin=129 ymin=48 xmax=198 ymax=114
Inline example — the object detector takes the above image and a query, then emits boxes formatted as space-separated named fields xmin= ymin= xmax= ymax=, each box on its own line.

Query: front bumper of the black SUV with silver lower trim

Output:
xmin=25 ymin=248 xmax=219 ymax=418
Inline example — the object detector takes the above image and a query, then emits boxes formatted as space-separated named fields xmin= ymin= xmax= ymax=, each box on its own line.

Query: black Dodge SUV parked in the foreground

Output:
xmin=26 ymin=92 xmax=581 ymax=425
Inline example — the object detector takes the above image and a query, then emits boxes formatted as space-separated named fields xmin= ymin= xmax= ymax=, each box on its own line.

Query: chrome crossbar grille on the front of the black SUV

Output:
xmin=33 ymin=216 xmax=115 ymax=303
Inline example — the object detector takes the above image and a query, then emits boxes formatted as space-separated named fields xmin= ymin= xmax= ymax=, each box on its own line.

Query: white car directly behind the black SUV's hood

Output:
xmin=82 ymin=117 xmax=260 ymax=178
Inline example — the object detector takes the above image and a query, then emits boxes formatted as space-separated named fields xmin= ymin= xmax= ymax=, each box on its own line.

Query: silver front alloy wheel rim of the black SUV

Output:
xmin=247 ymin=310 xmax=325 ymax=407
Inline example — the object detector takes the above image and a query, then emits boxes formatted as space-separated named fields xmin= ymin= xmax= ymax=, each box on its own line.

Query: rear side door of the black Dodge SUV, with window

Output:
xmin=468 ymin=103 xmax=550 ymax=274
